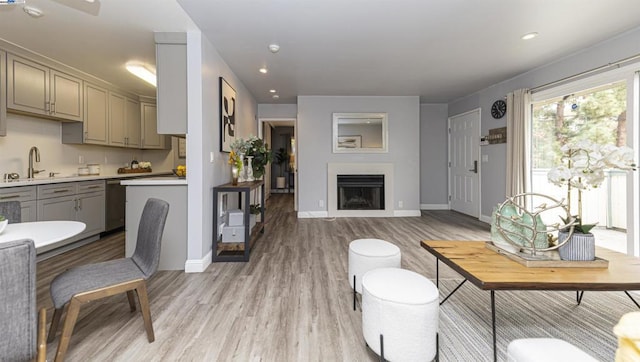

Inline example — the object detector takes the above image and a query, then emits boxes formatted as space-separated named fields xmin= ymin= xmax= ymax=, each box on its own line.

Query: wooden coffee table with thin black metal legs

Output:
xmin=420 ymin=240 xmax=640 ymax=361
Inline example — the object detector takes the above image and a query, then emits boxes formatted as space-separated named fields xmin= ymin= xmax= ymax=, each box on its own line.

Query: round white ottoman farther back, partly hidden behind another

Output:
xmin=349 ymin=239 xmax=400 ymax=310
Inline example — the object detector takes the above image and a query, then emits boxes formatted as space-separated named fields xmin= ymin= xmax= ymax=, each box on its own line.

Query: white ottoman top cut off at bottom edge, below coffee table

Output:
xmin=507 ymin=338 xmax=598 ymax=362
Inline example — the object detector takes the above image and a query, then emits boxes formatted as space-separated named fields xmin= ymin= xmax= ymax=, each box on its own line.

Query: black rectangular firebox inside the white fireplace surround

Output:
xmin=337 ymin=175 xmax=385 ymax=210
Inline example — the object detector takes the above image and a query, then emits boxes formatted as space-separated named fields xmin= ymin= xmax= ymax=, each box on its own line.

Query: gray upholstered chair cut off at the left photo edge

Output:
xmin=0 ymin=239 xmax=47 ymax=361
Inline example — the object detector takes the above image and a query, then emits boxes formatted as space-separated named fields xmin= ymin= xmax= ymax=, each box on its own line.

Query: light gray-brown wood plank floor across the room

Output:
xmin=37 ymin=194 xmax=489 ymax=361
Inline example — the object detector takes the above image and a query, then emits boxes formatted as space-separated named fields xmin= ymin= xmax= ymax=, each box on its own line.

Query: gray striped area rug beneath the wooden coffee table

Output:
xmin=440 ymin=280 xmax=640 ymax=362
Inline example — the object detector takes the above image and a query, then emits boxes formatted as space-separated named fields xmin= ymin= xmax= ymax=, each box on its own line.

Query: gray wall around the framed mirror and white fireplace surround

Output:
xmin=297 ymin=96 xmax=420 ymax=212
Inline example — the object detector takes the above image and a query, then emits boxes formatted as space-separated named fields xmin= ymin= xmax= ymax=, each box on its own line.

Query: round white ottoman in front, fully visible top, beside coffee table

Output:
xmin=362 ymin=268 xmax=439 ymax=362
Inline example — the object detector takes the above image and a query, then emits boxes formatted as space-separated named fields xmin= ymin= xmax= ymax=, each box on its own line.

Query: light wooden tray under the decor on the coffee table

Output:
xmin=484 ymin=241 xmax=609 ymax=268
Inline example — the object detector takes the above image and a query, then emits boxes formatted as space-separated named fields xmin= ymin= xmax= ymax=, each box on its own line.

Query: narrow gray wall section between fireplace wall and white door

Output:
xmin=420 ymin=104 xmax=449 ymax=209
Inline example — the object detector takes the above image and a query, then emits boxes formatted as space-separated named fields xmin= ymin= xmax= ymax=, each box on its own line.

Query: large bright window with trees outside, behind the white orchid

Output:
xmin=531 ymin=80 xmax=629 ymax=253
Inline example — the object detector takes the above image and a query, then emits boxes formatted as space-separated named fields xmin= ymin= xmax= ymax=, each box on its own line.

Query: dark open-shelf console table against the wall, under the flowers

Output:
xmin=212 ymin=180 xmax=265 ymax=262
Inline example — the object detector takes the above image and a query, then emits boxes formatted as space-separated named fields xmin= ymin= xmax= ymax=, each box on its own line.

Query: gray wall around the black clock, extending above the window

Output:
xmin=449 ymin=28 xmax=640 ymax=219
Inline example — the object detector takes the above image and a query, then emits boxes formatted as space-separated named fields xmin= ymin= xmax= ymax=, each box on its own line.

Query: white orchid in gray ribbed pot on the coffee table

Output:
xmin=547 ymin=140 xmax=636 ymax=260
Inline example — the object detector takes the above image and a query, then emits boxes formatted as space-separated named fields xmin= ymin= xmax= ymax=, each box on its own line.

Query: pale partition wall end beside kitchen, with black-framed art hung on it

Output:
xmin=186 ymin=32 xmax=257 ymax=271
